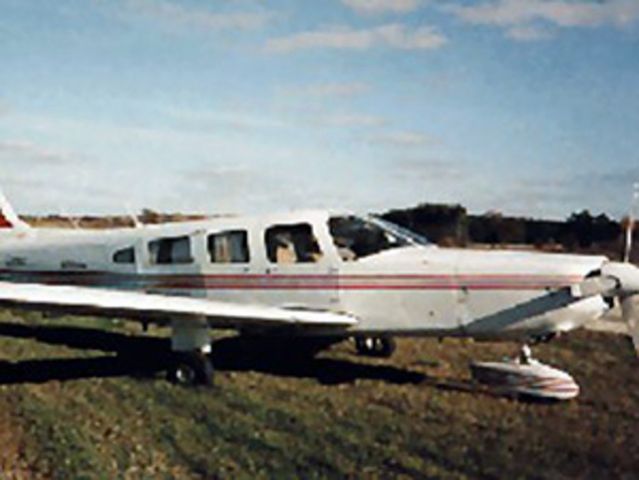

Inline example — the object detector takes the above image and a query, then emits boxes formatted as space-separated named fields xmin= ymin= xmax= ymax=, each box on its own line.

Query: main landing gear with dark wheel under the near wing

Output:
xmin=167 ymin=322 xmax=213 ymax=387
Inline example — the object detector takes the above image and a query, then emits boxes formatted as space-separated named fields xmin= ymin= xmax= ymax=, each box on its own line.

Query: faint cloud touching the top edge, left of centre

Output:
xmin=125 ymin=0 xmax=272 ymax=30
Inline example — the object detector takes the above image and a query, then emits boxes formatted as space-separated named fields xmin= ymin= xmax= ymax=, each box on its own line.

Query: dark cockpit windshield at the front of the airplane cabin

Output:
xmin=329 ymin=215 xmax=429 ymax=261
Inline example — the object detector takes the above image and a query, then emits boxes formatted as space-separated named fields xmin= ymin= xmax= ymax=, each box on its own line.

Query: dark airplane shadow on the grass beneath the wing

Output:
xmin=0 ymin=323 xmax=427 ymax=385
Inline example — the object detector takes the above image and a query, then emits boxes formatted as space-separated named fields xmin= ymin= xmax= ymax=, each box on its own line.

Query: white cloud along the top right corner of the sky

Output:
xmin=444 ymin=0 xmax=639 ymax=30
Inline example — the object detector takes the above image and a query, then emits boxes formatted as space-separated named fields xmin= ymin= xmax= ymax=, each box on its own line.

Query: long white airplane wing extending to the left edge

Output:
xmin=0 ymin=282 xmax=357 ymax=329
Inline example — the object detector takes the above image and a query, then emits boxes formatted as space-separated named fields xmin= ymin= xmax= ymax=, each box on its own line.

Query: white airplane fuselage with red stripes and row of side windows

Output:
xmin=0 ymin=212 xmax=607 ymax=338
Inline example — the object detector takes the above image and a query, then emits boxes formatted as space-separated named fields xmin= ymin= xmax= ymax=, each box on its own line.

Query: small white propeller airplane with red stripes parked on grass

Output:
xmin=0 ymin=191 xmax=639 ymax=396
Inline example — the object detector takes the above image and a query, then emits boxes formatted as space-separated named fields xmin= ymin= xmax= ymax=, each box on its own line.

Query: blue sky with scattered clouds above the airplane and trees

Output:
xmin=0 ymin=0 xmax=639 ymax=218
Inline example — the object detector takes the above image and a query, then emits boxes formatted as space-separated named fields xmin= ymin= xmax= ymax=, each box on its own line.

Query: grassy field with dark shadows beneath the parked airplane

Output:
xmin=0 ymin=311 xmax=639 ymax=479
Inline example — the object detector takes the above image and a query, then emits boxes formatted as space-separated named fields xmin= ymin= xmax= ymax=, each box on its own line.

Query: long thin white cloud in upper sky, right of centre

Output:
xmin=266 ymin=23 xmax=448 ymax=53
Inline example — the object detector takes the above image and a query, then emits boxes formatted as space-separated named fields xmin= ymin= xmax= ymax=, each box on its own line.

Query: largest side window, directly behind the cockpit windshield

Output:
xmin=265 ymin=223 xmax=322 ymax=264
